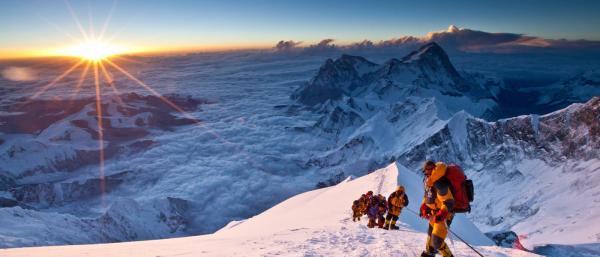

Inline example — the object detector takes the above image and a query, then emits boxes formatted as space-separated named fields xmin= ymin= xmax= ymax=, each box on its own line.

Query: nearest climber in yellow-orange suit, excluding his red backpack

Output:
xmin=420 ymin=161 xmax=454 ymax=257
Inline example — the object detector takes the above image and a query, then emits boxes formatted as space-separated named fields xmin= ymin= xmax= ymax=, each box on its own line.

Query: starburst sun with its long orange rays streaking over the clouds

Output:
xmin=23 ymin=1 xmax=263 ymax=208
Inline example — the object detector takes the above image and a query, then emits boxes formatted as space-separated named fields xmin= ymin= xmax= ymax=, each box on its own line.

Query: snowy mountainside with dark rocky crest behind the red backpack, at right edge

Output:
xmin=398 ymin=97 xmax=600 ymax=247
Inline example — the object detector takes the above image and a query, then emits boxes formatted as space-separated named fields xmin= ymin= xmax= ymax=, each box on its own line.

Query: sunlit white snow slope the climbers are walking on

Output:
xmin=0 ymin=163 xmax=537 ymax=257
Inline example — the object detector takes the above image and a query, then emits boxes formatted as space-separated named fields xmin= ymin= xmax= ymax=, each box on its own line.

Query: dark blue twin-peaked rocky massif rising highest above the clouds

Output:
xmin=292 ymin=43 xmax=497 ymax=118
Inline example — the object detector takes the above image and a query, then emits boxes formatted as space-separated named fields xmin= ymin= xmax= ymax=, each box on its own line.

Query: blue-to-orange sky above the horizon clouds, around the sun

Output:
xmin=0 ymin=0 xmax=600 ymax=58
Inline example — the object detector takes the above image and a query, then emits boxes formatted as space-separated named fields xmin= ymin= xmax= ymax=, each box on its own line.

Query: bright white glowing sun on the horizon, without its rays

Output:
xmin=59 ymin=40 xmax=127 ymax=62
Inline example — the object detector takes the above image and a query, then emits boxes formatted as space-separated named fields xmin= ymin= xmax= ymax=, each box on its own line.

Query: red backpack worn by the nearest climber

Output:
xmin=444 ymin=164 xmax=474 ymax=213
